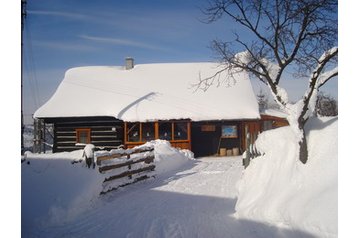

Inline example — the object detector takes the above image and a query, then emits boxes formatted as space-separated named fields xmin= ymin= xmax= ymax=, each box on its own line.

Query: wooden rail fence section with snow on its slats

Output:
xmin=94 ymin=147 xmax=155 ymax=194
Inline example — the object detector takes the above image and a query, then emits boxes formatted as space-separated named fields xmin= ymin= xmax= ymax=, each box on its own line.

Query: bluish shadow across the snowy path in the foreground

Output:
xmin=23 ymin=158 xmax=314 ymax=238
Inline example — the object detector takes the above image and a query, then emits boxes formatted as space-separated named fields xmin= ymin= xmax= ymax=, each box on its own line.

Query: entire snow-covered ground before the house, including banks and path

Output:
xmin=21 ymin=118 xmax=338 ymax=238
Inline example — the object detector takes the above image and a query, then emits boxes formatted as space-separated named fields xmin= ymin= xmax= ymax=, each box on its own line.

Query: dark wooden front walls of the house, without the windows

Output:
xmin=45 ymin=116 xmax=288 ymax=157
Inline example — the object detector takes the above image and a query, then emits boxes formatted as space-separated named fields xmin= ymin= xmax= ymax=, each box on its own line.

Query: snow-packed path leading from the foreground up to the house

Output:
xmin=34 ymin=157 xmax=311 ymax=238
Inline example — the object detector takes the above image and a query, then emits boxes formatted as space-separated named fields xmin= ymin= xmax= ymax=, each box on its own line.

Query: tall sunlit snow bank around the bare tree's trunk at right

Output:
xmin=236 ymin=118 xmax=338 ymax=237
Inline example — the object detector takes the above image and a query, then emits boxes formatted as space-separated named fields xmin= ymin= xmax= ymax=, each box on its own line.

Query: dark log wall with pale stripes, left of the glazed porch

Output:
xmin=52 ymin=117 xmax=123 ymax=152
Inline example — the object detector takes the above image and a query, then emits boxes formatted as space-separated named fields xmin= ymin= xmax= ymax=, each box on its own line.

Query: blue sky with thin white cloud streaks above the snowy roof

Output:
xmin=23 ymin=0 xmax=338 ymax=122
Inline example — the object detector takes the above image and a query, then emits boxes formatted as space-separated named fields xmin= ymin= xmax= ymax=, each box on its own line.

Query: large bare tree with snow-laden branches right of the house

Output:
xmin=198 ymin=0 xmax=338 ymax=163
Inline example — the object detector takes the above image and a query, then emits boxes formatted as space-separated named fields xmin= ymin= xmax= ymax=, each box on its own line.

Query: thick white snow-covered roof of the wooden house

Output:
xmin=34 ymin=63 xmax=260 ymax=121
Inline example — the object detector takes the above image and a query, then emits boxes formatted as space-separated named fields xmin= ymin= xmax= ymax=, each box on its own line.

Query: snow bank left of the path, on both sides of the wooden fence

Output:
xmin=21 ymin=140 xmax=193 ymax=234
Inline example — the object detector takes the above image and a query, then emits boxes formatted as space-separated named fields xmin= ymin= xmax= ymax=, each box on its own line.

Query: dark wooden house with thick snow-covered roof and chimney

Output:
xmin=34 ymin=59 xmax=282 ymax=156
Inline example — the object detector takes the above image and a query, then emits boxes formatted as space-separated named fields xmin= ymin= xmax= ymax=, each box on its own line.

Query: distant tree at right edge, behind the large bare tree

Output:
xmin=315 ymin=92 xmax=338 ymax=117
